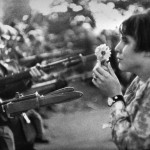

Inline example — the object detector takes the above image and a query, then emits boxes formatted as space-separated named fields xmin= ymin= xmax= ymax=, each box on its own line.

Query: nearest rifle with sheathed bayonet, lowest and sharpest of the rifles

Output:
xmin=0 ymin=87 xmax=83 ymax=117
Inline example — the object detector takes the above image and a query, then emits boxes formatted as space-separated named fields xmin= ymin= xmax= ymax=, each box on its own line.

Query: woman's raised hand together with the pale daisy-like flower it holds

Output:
xmin=92 ymin=44 xmax=121 ymax=97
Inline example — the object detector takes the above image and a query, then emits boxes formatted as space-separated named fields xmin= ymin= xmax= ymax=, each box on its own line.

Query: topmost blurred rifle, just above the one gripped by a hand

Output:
xmin=18 ymin=50 xmax=83 ymax=67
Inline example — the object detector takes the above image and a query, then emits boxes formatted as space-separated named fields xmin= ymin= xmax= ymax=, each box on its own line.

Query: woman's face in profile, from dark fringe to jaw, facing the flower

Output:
xmin=115 ymin=36 xmax=142 ymax=73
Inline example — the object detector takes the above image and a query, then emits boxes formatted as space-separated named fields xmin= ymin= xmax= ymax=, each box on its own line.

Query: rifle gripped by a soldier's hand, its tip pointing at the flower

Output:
xmin=0 ymin=54 xmax=96 ymax=87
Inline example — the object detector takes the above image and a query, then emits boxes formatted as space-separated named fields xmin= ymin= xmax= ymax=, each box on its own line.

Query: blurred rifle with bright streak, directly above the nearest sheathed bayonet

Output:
xmin=23 ymin=70 xmax=92 ymax=94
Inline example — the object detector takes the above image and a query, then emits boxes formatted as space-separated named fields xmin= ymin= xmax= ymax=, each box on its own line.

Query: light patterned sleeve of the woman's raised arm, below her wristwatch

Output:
xmin=111 ymin=79 xmax=150 ymax=150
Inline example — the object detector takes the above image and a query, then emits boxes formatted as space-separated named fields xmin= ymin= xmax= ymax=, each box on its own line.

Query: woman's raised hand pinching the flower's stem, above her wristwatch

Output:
xmin=92 ymin=62 xmax=122 ymax=97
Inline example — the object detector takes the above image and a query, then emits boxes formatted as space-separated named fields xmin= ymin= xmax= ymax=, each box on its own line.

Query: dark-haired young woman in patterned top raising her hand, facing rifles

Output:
xmin=92 ymin=10 xmax=150 ymax=150
